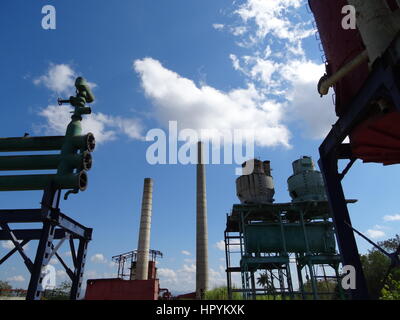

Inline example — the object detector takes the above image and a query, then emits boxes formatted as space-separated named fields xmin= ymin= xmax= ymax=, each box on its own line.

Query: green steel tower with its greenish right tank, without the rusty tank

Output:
xmin=225 ymin=157 xmax=345 ymax=299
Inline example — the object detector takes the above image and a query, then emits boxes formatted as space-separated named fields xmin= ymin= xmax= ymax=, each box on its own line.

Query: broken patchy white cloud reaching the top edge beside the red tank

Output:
xmin=225 ymin=0 xmax=337 ymax=139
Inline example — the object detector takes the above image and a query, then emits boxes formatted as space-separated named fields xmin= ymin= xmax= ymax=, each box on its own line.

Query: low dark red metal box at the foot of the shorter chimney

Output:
xmin=85 ymin=278 xmax=160 ymax=300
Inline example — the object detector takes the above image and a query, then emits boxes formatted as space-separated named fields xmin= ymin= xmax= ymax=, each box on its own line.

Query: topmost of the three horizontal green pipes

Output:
xmin=0 ymin=133 xmax=96 ymax=152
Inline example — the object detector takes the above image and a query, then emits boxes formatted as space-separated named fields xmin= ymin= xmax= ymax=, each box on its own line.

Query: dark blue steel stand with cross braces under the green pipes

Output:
xmin=0 ymin=187 xmax=92 ymax=300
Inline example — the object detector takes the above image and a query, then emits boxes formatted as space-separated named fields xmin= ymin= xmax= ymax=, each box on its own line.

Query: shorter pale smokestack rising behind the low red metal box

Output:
xmin=136 ymin=178 xmax=153 ymax=280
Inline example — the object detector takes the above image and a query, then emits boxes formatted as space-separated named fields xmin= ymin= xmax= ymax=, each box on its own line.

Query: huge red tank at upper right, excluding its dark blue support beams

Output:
xmin=309 ymin=0 xmax=400 ymax=165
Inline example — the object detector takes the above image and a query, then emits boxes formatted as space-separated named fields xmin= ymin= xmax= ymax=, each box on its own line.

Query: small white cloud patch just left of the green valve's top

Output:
xmin=33 ymin=64 xmax=77 ymax=95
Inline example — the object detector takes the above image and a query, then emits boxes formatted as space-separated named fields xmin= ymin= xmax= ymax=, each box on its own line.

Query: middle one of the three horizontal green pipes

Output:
xmin=0 ymin=151 xmax=92 ymax=171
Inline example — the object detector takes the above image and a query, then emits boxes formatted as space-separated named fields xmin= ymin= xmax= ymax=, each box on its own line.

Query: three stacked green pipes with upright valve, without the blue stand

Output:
xmin=0 ymin=77 xmax=95 ymax=198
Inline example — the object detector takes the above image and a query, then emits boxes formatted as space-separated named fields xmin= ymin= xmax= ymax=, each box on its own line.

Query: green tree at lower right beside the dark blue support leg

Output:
xmin=361 ymin=235 xmax=400 ymax=300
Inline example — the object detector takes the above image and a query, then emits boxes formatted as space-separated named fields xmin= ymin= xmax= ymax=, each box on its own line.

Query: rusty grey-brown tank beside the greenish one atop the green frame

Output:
xmin=236 ymin=159 xmax=275 ymax=204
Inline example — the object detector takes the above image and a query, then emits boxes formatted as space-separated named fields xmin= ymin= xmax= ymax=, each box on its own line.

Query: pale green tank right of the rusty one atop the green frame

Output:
xmin=287 ymin=156 xmax=327 ymax=202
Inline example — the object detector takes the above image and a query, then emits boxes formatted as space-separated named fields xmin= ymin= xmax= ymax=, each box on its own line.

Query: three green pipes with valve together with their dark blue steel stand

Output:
xmin=0 ymin=77 xmax=95 ymax=300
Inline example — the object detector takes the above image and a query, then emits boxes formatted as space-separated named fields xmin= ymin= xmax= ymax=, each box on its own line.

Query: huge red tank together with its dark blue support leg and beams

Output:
xmin=309 ymin=0 xmax=400 ymax=299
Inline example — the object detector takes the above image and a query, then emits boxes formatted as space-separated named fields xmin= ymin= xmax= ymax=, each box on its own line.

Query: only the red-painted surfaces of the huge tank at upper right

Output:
xmin=309 ymin=0 xmax=400 ymax=165
